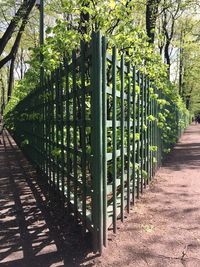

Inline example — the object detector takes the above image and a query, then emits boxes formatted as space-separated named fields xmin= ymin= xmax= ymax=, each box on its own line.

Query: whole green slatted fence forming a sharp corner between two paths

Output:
xmin=7 ymin=33 xmax=187 ymax=252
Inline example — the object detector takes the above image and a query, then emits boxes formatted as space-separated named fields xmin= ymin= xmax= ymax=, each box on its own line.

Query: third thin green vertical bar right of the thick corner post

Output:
xmin=120 ymin=54 xmax=125 ymax=222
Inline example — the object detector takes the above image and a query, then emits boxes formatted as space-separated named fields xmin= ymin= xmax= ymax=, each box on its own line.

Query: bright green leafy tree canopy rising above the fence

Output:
xmin=0 ymin=0 xmax=200 ymax=112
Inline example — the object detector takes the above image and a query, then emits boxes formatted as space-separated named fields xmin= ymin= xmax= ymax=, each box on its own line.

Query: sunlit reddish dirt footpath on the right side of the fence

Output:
xmin=88 ymin=125 xmax=200 ymax=267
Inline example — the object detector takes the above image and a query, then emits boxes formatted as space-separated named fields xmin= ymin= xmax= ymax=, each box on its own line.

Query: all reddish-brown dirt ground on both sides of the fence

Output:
xmin=0 ymin=125 xmax=200 ymax=267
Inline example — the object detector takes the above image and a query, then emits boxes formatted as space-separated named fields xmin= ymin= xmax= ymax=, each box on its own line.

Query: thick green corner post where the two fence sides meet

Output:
xmin=91 ymin=32 xmax=103 ymax=253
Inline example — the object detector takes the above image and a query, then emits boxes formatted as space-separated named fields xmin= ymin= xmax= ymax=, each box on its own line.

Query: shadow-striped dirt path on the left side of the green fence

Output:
xmin=0 ymin=134 xmax=95 ymax=267
